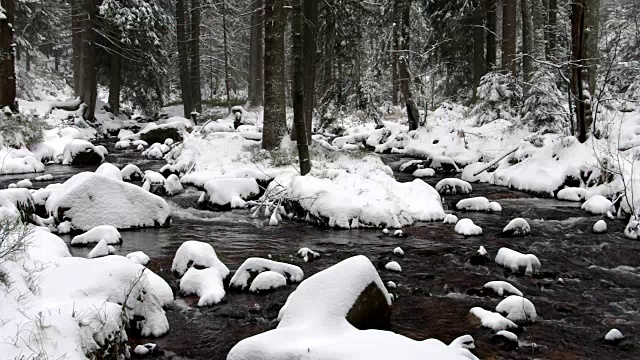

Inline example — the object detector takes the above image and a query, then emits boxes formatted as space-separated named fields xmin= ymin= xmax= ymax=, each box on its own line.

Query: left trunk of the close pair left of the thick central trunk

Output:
xmin=176 ymin=0 xmax=193 ymax=118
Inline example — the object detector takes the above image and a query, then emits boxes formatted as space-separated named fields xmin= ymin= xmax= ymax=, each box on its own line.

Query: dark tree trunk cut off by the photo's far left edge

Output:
xmin=0 ymin=0 xmax=18 ymax=113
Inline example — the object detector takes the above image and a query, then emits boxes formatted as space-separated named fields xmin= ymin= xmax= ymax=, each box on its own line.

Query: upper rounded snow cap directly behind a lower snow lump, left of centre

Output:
xmin=171 ymin=240 xmax=229 ymax=279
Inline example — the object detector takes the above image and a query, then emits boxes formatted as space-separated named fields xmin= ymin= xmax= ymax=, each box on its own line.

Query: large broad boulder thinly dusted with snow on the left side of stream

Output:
xmin=46 ymin=172 xmax=171 ymax=230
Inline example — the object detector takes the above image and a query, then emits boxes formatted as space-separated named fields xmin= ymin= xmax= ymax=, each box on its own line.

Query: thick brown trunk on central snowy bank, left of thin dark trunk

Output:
xmin=262 ymin=0 xmax=287 ymax=150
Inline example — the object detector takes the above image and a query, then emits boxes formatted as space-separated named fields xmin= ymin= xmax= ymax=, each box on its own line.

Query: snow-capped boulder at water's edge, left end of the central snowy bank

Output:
xmin=198 ymin=178 xmax=261 ymax=211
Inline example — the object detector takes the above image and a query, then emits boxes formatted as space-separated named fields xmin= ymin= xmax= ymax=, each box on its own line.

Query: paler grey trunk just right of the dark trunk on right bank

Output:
xmin=584 ymin=0 xmax=600 ymax=96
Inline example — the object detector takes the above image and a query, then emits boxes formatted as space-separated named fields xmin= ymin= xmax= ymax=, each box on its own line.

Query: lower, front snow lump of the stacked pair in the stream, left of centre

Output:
xmin=180 ymin=267 xmax=226 ymax=306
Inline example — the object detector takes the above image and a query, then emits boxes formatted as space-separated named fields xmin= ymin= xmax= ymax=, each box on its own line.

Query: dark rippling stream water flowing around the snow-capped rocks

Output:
xmin=0 ymin=142 xmax=640 ymax=359
